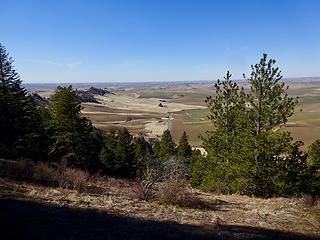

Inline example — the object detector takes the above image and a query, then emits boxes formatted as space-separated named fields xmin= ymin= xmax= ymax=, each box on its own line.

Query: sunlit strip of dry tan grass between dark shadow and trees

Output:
xmin=0 ymin=172 xmax=320 ymax=236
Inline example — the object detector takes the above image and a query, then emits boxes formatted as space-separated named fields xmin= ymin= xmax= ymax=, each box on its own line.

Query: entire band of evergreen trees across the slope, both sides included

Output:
xmin=0 ymin=45 xmax=320 ymax=197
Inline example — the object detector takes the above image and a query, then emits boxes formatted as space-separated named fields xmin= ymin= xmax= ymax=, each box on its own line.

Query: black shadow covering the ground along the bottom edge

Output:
xmin=0 ymin=199 xmax=318 ymax=240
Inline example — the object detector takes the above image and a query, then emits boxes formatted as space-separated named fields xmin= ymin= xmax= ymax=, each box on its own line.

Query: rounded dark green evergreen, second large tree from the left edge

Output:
xmin=48 ymin=86 xmax=100 ymax=168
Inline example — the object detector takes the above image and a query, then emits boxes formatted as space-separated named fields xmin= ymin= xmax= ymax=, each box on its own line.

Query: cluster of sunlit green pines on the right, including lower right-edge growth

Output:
xmin=191 ymin=54 xmax=320 ymax=197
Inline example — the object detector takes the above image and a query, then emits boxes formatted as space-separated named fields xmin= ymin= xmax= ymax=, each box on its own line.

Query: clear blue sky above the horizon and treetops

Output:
xmin=0 ymin=0 xmax=320 ymax=83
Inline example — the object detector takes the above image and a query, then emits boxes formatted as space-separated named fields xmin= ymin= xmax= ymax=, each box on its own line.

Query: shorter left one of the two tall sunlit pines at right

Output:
xmin=198 ymin=72 xmax=253 ymax=192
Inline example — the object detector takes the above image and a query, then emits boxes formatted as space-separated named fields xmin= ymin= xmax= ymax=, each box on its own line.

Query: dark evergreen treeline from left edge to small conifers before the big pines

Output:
xmin=0 ymin=42 xmax=192 ymax=178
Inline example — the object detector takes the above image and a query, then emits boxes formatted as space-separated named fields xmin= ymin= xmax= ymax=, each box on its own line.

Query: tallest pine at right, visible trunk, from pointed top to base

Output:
xmin=248 ymin=54 xmax=297 ymax=195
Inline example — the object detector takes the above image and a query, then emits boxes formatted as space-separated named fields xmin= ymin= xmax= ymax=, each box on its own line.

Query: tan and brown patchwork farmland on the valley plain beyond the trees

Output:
xmin=32 ymin=78 xmax=320 ymax=149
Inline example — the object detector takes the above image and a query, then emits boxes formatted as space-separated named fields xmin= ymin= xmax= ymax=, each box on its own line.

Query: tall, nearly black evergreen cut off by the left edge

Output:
xmin=0 ymin=44 xmax=45 ymax=159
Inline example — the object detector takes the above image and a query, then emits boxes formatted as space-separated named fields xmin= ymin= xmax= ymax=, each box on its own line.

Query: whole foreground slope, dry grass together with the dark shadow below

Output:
xmin=0 ymin=178 xmax=320 ymax=239
